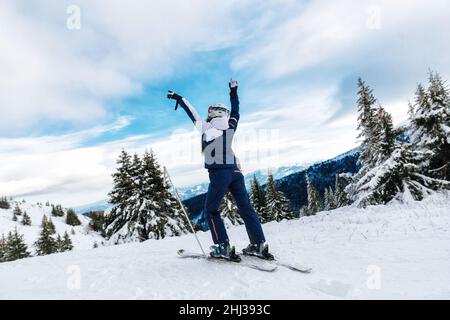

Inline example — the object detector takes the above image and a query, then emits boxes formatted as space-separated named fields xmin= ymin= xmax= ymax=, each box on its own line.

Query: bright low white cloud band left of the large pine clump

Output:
xmin=0 ymin=117 xmax=130 ymax=202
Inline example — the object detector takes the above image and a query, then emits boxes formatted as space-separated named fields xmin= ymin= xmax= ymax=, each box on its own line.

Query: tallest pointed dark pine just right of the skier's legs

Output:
xmin=262 ymin=172 xmax=294 ymax=222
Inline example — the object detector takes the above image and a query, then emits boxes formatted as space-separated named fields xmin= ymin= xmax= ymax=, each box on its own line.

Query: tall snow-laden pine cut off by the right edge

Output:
xmin=410 ymin=72 xmax=450 ymax=182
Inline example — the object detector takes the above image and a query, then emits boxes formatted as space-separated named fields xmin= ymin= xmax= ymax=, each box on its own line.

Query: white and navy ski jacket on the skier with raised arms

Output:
xmin=179 ymin=94 xmax=240 ymax=170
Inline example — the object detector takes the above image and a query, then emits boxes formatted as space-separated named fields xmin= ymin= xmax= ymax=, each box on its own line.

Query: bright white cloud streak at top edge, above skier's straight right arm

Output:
xmin=233 ymin=1 xmax=365 ymax=78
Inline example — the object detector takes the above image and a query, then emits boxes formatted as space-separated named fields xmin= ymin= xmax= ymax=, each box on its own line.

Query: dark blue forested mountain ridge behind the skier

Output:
xmin=184 ymin=148 xmax=360 ymax=216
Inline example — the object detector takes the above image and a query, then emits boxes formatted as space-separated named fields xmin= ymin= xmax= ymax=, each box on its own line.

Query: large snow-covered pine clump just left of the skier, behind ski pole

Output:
xmin=107 ymin=151 xmax=189 ymax=243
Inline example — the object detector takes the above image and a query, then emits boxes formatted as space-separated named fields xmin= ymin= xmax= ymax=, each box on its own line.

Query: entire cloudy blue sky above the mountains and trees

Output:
xmin=0 ymin=0 xmax=450 ymax=206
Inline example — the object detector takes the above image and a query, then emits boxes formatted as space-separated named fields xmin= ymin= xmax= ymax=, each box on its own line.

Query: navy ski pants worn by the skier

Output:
xmin=204 ymin=169 xmax=265 ymax=244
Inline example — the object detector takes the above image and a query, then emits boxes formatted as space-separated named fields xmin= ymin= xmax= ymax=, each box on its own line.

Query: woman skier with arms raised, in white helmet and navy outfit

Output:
xmin=167 ymin=80 xmax=274 ymax=262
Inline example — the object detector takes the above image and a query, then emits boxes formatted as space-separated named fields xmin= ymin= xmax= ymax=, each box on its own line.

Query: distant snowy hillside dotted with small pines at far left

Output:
xmin=0 ymin=203 xmax=104 ymax=254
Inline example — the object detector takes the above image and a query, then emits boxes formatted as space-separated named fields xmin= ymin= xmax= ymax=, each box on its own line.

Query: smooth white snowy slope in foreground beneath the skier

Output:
xmin=0 ymin=194 xmax=450 ymax=299
